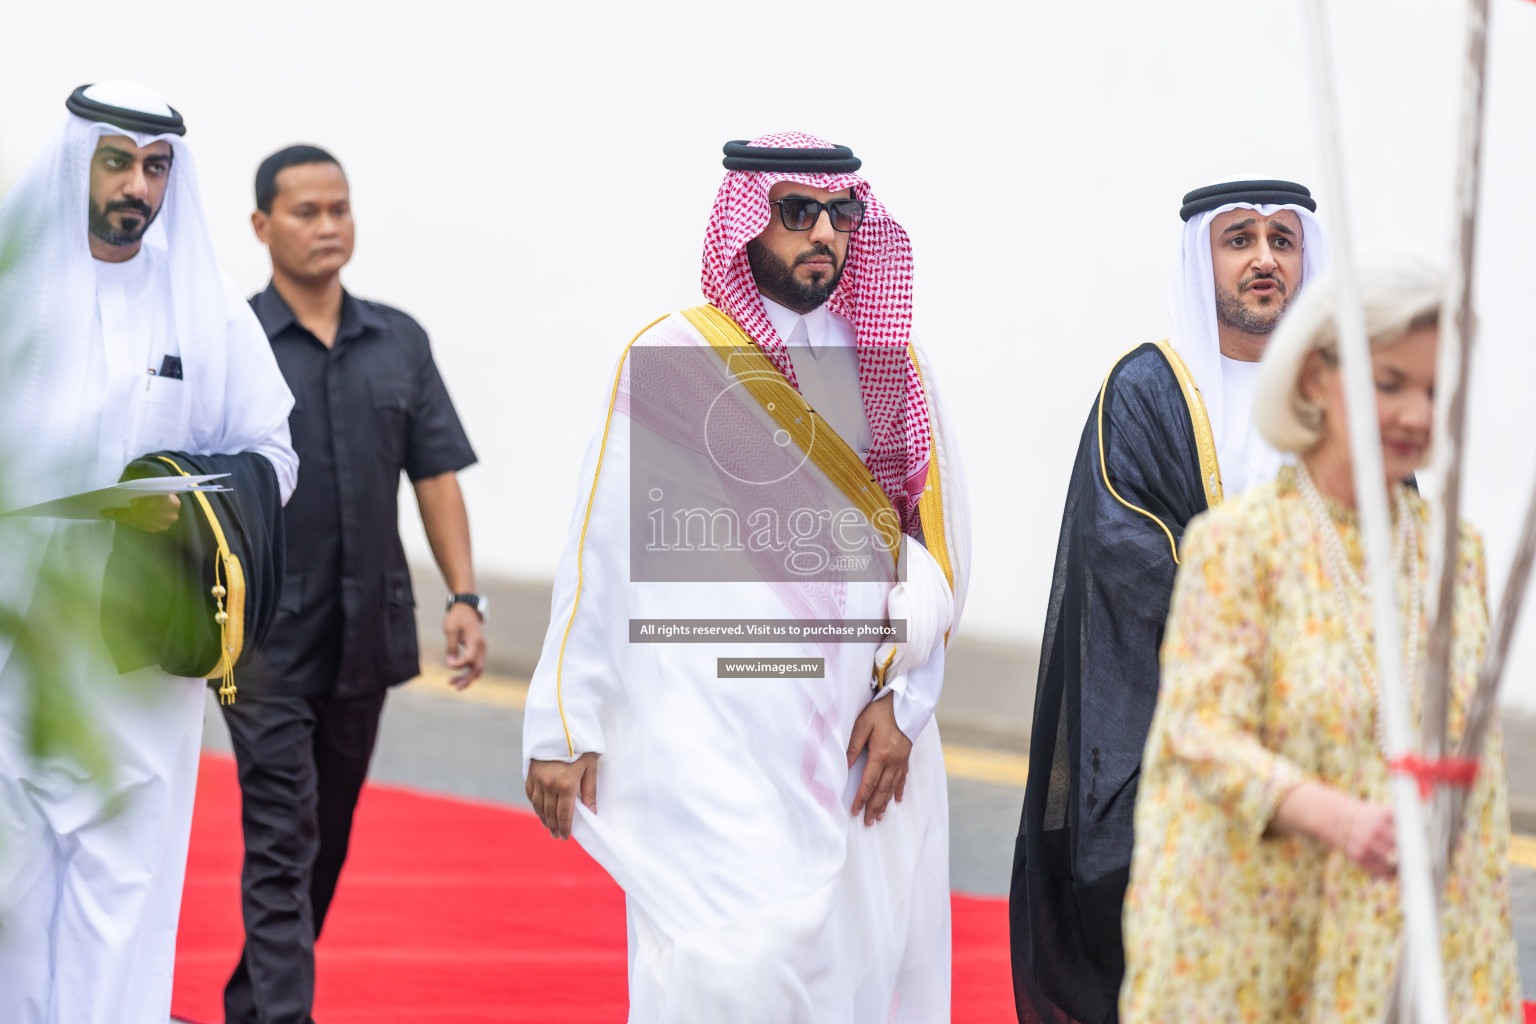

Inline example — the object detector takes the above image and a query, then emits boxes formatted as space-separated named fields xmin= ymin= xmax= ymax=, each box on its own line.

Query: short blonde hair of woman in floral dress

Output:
xmin=1253 ymin=256 xmax=1445 ymax=453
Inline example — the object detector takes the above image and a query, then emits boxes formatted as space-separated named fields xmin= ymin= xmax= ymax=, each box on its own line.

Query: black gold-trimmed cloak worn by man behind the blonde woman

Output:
xmin=1009 ymin=344 xmax=1221 ymax=1024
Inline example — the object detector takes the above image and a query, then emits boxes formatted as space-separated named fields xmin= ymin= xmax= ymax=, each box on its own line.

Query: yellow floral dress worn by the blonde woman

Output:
xmin=1120 ymin=468 xmax=1521 ymax=1024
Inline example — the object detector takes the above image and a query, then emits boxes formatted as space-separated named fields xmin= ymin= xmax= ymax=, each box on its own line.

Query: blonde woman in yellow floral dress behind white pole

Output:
xmin=1120 ymin=263 xmax=1521 ymax=1024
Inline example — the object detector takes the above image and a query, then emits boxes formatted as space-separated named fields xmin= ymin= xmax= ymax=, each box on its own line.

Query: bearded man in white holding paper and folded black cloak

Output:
xmin=0 ymin=81 xmax=298 ymax=1024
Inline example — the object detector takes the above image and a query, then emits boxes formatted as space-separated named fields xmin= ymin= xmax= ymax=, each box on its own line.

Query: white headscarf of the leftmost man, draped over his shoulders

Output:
xmin=0 ymin=81 xmax=293 ymax=668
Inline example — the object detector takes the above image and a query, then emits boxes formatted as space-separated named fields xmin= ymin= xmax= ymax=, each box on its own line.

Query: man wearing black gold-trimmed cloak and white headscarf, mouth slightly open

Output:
xmin=1009 ymin=180 xmax=1327 ymax=1024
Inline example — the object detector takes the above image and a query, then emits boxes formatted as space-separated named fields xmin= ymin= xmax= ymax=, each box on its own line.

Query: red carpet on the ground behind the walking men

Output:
xmin=172 ymin=757 xmax=1014 ymax=1024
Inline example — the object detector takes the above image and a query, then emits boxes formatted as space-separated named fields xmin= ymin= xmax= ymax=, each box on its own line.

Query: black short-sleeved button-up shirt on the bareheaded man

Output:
xmin=238 ymin=284 xmax=475 ymax=697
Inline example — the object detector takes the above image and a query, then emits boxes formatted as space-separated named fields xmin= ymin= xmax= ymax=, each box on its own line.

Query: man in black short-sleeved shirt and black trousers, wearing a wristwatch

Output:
xmin=224 ymin=146 xmax=485 ymax=1024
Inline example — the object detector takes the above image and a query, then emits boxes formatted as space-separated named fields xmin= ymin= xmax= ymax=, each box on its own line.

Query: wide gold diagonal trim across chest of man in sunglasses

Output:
xmin=682 ymin=306 xmax=902 ymax=562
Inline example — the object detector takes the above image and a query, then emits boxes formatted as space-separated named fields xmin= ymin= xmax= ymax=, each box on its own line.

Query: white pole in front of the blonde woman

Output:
xmin=1306 ymin=0 xmax=1447 ymax=1024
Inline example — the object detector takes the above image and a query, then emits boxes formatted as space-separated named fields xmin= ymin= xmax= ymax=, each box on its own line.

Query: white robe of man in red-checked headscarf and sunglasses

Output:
xmin=524 ymin=302 xmax=969 ymax=1024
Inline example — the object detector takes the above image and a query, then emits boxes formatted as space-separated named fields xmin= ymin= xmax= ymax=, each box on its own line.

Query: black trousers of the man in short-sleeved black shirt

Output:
xmin=223 ymin=691 xmax=384 ymax=1024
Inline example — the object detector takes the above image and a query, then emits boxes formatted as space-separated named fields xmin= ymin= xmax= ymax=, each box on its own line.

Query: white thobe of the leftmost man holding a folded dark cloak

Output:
xmin=0 ymin=246 xmax=298 ymax=1024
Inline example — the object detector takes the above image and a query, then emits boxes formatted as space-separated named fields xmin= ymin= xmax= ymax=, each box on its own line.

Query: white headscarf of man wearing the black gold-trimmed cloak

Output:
xmin=1167 ymin=175 xmax=1329 ymax=497
